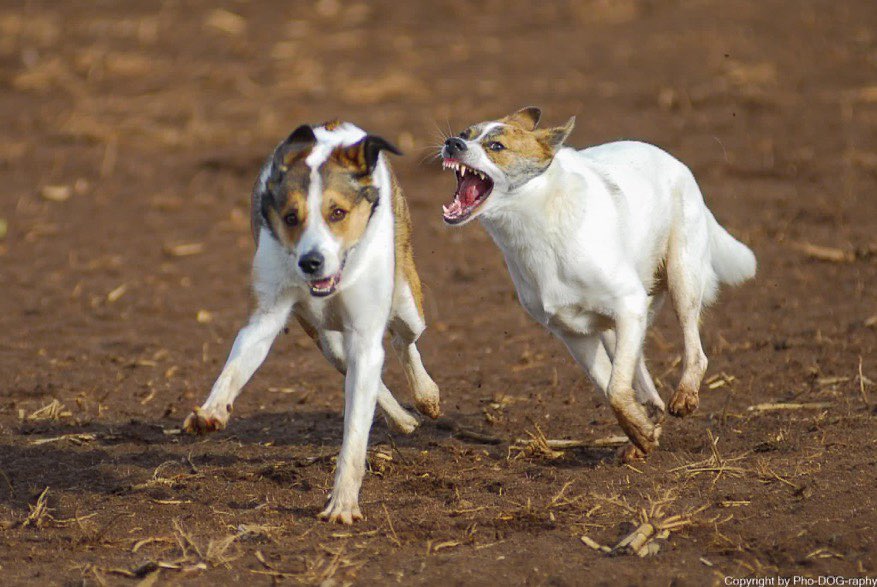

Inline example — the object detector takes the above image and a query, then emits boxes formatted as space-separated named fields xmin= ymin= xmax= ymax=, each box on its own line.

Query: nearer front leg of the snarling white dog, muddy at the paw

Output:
xmin=608 ymin=296 xmax=661 ymax=453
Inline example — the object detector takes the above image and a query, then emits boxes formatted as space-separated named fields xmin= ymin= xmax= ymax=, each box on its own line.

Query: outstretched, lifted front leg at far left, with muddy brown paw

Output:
xmin=183 ymin=300 xmax=292 ymax=434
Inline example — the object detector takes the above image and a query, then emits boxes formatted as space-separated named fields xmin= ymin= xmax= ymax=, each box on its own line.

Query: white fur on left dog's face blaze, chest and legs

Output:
xmin=193 ymin=123 xmax=437 ymax=523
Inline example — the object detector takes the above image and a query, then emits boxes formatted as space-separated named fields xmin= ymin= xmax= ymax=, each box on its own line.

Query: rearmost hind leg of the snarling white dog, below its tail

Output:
xmin=667 ymin=231 xmax=712 ymax=417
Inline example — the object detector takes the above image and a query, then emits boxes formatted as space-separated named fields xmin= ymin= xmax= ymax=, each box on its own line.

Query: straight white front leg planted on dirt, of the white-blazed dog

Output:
xmin=320 ymin=332 xmax=384 ymax=524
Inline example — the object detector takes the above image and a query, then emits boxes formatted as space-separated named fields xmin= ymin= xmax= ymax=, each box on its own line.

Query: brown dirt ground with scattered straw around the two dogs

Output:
xmin=0 ymin=0 xmax=877 ymax=585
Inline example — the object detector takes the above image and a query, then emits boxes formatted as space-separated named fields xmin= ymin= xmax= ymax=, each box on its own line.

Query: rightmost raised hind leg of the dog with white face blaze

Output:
xmin=390 ymin=278 xmax=441 ymax=418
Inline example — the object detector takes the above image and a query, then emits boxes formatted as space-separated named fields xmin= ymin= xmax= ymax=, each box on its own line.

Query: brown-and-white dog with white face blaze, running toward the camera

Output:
xmin=183 ymin=122 xmax=439 ymax=524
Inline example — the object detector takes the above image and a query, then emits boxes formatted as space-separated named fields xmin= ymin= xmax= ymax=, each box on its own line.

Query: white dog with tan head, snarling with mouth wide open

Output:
xmin=441 ymin=108 xmax=755 ymax=458
